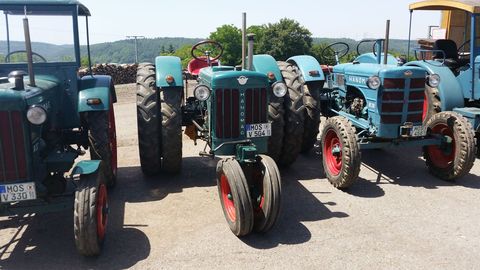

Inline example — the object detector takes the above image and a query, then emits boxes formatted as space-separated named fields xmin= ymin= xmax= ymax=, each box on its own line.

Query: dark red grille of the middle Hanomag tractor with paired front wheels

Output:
xmin=215 ymin=88 xmax=267 ymax=139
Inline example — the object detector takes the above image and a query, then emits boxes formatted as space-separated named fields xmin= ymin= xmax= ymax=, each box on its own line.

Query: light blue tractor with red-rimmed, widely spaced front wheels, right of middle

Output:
xmin=288 ymin=33 xmax=475 ymax=189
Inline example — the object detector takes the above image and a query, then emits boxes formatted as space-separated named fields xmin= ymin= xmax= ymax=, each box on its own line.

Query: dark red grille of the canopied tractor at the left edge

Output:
xmin=0 ymin=111 xmax=27 ymax=183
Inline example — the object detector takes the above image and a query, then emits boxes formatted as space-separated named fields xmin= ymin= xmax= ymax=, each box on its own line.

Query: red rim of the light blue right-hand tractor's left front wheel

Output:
xmin=323 ymin=129 xmax=342 ymax=176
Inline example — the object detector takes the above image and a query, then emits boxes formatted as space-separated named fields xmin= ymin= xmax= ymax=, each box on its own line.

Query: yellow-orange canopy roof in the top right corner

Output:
xmin=409 ymin=0 xmax=480 ymax=14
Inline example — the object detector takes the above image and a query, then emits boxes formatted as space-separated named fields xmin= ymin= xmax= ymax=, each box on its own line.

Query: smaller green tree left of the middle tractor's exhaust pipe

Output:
xmin=209 ymin=24 xmax=242 ymax=66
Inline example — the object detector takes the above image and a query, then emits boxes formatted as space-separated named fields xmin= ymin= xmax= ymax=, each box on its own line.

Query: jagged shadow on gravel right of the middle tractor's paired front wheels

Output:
xmin=241 ymin=153 xmax=348 ymax=249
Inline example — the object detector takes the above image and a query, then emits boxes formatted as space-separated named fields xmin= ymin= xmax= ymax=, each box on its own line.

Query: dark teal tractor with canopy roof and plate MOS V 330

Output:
xmin=0 ymin=0 xmax=117 ymax=256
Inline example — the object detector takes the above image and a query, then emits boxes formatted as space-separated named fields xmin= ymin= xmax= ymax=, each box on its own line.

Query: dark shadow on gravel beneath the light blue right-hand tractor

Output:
xmin=362 ymin=148 xmax=480 ymax=189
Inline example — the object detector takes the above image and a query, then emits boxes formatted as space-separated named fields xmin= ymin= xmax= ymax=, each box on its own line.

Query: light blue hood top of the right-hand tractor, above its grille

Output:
xmin=333 ymin=63 xmax=426 ymax=80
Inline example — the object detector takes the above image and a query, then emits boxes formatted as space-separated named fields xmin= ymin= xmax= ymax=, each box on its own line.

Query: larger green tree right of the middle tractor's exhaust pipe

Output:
xmin=258 ymin=18 xmax=312 ymax=60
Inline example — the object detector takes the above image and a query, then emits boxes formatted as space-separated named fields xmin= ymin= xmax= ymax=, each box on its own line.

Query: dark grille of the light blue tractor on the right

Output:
xmin=380 ymin=78 xmax=425 ymax=124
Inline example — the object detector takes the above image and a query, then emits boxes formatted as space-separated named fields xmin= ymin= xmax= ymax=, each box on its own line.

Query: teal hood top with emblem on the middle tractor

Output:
xmin=199 ymin=67 xmax=269 ymax=88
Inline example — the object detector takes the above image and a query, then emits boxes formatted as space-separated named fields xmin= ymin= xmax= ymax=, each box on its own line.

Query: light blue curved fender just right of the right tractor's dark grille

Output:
xmin=405 ymin=61 xmax=465 ymax=111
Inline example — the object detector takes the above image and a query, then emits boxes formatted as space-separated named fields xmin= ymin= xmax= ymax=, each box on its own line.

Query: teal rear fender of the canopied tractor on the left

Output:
xmin=78 ymin=75 xmax=117 ymax=112
